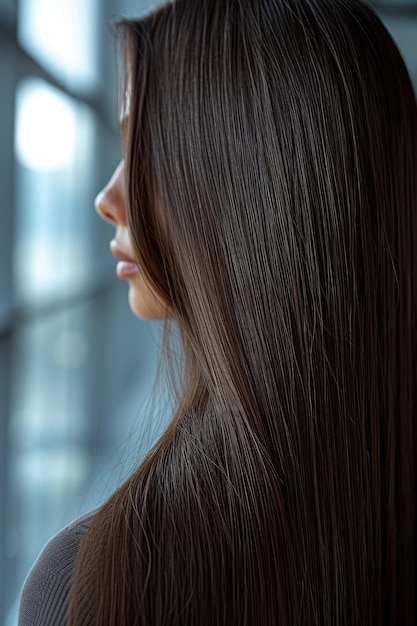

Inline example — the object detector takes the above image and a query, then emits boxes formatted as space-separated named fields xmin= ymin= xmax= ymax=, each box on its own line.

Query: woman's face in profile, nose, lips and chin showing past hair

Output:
xmin=95 ymin=161 xmax=167 ymax=320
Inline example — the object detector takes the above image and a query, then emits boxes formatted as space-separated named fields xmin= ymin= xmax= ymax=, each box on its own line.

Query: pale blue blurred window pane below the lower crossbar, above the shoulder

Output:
xmin=6 ymin=309 xmax=92 ymax=624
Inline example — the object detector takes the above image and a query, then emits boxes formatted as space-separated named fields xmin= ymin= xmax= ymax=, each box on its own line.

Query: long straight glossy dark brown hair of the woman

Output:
xmin=70 ymin=0 xmax=417 ymax=626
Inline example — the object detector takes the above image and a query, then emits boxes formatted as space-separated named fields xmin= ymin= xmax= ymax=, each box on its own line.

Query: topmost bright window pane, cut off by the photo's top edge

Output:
xmin=18 ymin=0 xmax=101 ymax=89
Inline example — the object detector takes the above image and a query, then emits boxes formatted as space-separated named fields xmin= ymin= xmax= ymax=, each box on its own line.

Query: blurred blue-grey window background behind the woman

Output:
xmin=0 ymin=0 xmax=417 ymax=626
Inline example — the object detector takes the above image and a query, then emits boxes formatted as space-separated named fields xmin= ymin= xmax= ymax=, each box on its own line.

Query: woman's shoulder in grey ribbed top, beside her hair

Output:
xmin=19 ymin=510 xmax=96 ymax=626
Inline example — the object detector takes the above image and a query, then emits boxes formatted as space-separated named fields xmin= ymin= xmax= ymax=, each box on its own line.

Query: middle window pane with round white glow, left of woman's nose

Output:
xmin=13 ymin=79 xmax=98 ymax=303
